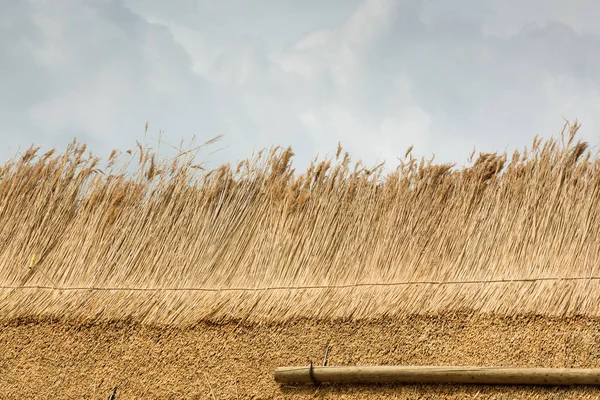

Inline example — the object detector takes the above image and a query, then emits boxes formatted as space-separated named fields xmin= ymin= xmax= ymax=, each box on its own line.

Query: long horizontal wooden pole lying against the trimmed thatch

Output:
xmin=275 ymin=366 xmax=600 ymax=386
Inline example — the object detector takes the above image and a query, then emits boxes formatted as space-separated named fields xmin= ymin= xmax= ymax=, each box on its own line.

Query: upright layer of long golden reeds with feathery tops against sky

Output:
xmin=0 ymin=125 xmax=600 ymax=323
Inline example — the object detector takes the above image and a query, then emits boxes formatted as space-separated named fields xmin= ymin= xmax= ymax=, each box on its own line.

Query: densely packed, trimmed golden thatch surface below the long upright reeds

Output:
xmin=0 ymin=314 xmax=600 ymax=400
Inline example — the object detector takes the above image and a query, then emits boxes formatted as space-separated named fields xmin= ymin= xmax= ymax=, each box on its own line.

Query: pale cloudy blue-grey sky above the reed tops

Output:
xmin=0 ymin=0 xmax=600 ymax=169
